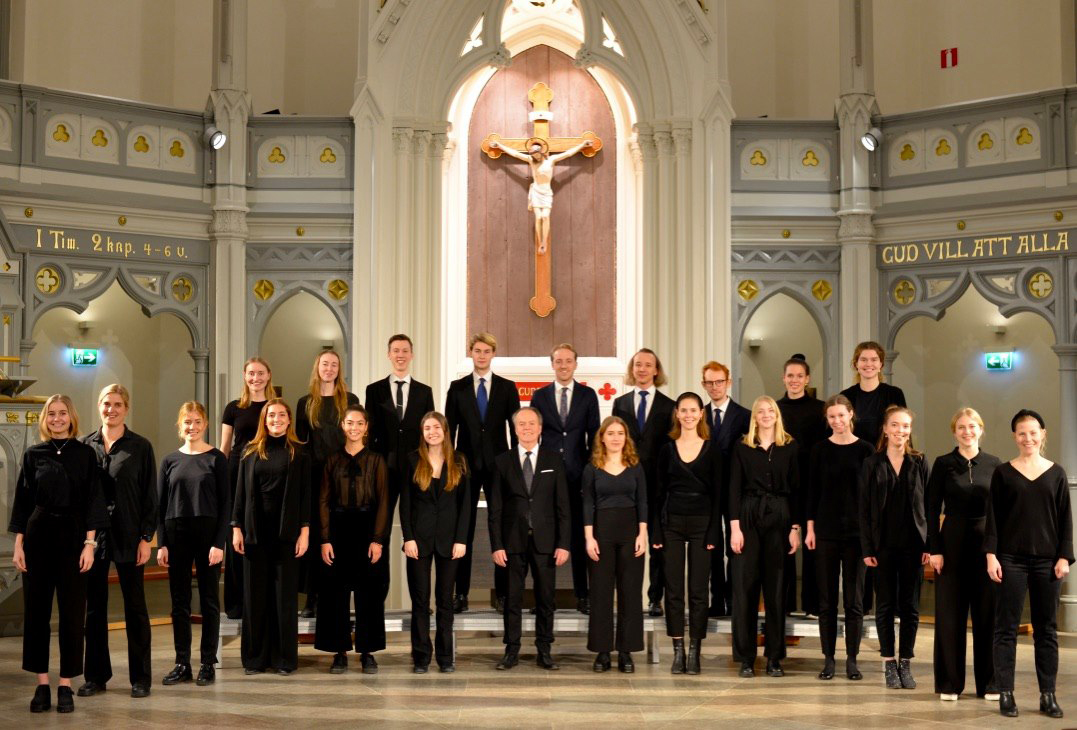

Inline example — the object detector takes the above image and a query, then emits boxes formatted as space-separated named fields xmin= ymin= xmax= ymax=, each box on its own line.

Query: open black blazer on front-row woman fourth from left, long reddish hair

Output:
xmin=232 ymin=448 xmax=313 ymax=545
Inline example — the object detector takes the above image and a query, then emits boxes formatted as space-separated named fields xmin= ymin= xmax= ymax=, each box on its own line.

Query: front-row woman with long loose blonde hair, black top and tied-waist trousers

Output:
xmin=729 ymin=395 xmax=801 ymax=677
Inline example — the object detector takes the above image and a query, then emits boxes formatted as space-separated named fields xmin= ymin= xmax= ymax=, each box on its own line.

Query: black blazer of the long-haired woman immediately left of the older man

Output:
xmin=401 ymin=452 xmax=471 ymax=558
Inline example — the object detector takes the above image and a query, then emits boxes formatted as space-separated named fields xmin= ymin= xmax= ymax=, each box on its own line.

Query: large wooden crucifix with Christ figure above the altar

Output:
xmin=480 ymin=82 xmax=602 ymax=317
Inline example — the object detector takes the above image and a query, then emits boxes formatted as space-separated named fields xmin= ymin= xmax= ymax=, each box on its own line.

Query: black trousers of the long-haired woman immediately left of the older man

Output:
xmin=406 ymin=552 xmax=460 ymax=666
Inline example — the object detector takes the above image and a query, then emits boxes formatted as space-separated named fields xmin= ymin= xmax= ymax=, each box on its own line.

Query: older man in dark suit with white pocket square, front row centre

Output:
xmin=487 ymin=408 xmax=571 ymax=670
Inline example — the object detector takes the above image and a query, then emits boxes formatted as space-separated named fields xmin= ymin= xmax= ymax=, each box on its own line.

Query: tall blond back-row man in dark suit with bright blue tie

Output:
xmin=445 ymin=332 xmax=520 ymax=614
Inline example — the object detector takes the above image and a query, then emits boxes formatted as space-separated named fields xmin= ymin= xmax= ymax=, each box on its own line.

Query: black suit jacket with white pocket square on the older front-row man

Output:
xmin=486 ymin=446 xmax=571 ymax=553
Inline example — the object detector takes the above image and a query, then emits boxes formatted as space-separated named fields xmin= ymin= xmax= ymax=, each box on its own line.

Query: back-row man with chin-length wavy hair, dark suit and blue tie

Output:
xmin=613 ymin=348 xmax=674 ymax=616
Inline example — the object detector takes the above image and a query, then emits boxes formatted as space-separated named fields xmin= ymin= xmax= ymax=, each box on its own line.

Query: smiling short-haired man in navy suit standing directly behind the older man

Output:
xmin=531 ymin=342 xmax=599 ymax=614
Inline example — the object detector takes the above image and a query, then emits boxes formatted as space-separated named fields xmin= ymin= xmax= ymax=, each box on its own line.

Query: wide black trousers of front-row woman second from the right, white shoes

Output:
xmin=935 ymin=515 xmax=995 ymax=697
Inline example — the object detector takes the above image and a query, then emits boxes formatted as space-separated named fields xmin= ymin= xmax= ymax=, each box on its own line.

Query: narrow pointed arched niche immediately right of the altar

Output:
xmin=732 ymin=292 xmax=828 ymax=406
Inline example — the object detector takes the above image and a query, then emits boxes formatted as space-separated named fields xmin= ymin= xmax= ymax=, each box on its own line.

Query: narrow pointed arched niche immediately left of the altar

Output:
xmin=257 ymin=290 xmax=344 ymax=408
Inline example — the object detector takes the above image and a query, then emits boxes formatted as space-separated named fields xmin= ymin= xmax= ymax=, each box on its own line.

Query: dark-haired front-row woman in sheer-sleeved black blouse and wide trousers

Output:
xmin=314 ymin=406 xmax=389 ymax=674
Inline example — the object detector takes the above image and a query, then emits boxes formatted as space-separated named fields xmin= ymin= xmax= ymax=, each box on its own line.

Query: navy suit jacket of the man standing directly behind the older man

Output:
xmin=531 ymin=382 xmax=599 ymax=488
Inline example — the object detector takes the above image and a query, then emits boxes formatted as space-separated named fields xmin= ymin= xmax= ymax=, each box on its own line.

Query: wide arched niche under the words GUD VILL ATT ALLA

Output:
xmin=891 ymin=286 xmax=1055 ymax=460
